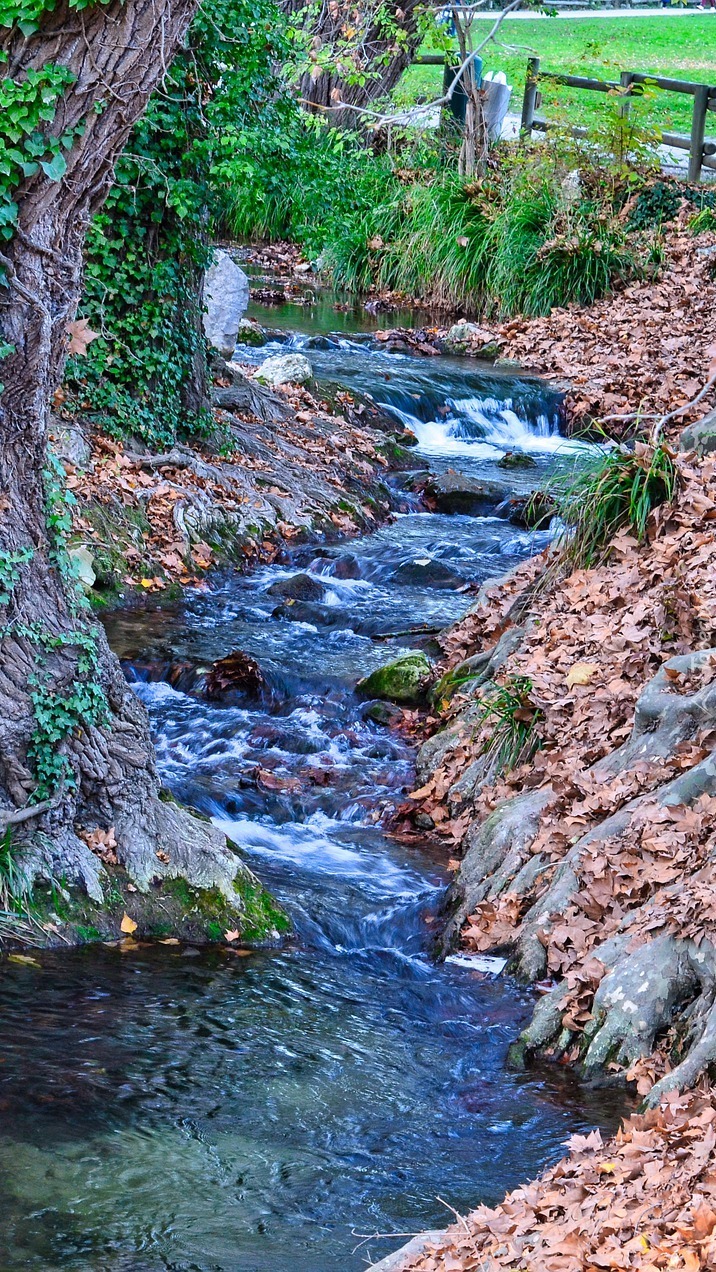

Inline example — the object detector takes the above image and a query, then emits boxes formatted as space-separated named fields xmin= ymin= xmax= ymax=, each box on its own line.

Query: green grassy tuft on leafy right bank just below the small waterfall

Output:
xmin=552 ymin=443 xmax=678 ymax=570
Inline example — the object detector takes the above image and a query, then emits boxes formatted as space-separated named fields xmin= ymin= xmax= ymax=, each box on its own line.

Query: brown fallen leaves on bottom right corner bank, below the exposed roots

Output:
xmin=401 ymin=1088 xmax=716 ymax=1272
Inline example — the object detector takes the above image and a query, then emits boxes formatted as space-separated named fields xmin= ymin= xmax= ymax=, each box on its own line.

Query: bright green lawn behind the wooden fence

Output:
xmin=394 ymin=11 xmax=716 ymax=136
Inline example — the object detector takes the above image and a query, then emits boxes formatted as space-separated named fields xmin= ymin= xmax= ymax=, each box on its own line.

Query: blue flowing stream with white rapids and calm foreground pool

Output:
xmin=0 ymin=305 xmax=619 ymax=1272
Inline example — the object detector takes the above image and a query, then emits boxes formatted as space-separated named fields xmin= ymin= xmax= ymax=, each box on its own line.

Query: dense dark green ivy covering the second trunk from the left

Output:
xmin=67 ymin=0 xmax=281 ymax=445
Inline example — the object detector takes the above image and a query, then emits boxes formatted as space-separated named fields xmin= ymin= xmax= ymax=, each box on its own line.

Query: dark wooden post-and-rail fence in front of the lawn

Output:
xmin=520 ymin=57 xmax=716 ymax=181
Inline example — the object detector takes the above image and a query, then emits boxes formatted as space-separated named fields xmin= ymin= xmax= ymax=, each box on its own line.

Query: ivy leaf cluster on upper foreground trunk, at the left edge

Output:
xmin=0 ymin=65 xmax=75 ymax=248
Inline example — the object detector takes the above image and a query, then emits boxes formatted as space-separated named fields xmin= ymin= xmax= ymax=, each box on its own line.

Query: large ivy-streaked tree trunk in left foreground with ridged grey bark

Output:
xmin=0 ymin=0 xmax=272 ymax=936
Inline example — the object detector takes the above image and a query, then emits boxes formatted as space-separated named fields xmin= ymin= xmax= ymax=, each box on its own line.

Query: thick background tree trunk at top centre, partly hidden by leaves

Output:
xmin=281 ymin=0 xmax=425 ymax=128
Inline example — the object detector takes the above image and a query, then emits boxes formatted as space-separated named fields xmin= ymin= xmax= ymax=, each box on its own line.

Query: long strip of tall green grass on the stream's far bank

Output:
xmin=221 ymin=106 xmax=649 ymax=317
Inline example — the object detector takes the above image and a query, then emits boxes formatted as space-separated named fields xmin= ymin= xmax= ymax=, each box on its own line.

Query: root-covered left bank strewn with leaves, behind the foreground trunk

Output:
xmin=53 ymin=364 xmax=415 ymax=604
